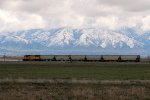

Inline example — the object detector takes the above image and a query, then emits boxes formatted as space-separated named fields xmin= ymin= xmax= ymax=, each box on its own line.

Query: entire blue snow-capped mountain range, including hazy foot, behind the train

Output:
xmin=0 ymin=28 xmax=150 ymax=54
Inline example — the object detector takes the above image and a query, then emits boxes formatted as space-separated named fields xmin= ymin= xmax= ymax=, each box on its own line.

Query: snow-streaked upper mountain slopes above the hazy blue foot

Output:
xmin=0 ymin=28 xmax=150 ymax=55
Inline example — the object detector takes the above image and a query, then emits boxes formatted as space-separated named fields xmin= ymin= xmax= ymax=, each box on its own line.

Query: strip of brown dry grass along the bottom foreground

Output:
xmin=0 ymin=83 xmax=150 ymax=100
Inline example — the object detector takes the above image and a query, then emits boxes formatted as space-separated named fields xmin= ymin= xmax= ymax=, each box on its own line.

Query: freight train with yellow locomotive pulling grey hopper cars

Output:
xmin=22 ymin=55 xmax=140 ymax=62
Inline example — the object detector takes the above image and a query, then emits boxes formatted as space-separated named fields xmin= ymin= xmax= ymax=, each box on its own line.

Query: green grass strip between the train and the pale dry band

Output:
xmin=0 ymin=62 xmax=150 ymax=80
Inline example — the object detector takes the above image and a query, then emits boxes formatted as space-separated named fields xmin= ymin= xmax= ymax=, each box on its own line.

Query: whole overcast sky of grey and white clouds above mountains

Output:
xmin=0 ymin=0 xmax=150 ymax=33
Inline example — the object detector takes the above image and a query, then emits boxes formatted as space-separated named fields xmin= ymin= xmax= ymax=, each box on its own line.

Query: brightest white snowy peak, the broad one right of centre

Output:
xmin=76 ymin=29 xmax=143 ymax=48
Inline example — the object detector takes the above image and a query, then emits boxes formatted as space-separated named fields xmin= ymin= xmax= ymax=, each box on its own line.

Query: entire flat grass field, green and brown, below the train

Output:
xmin=0 ymin=62 xmax=150 ymax=100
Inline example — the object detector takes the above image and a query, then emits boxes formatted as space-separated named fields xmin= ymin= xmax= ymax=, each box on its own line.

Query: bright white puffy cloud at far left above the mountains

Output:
xmin=0 ymin=10 xmax=45 ymax=31
